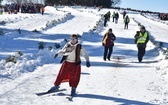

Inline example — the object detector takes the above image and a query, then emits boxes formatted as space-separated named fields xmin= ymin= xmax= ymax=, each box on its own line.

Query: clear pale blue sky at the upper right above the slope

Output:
xmin=120 ymin=0 xmax=168 ymax=13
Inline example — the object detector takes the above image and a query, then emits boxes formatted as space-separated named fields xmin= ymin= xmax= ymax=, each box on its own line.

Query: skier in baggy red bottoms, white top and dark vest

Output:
xmin=48 ymin=34 xmax=90 ymax=96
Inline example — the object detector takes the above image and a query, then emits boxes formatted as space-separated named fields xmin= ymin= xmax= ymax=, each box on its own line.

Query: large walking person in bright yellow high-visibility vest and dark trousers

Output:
xmin=134 ymin=26 xmax=149 ymax=62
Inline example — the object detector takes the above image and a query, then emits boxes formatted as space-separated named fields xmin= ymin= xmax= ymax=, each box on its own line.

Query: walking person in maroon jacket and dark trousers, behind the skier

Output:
xmin=102 ymin=28 xmax=116 ymax=61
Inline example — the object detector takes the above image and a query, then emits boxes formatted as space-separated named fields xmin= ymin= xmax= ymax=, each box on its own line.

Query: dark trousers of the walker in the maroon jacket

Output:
xmin=103 ymin=46 xmax=113 ymax=60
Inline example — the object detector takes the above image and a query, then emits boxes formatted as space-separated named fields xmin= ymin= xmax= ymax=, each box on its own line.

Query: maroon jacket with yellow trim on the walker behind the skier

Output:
xmin=102 ymin=33 xmax=116 ymax=47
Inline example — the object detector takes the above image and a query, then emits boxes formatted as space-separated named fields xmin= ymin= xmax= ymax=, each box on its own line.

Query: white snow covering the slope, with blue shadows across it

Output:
xmin=0 ymin=6 xmax=168 ymax=105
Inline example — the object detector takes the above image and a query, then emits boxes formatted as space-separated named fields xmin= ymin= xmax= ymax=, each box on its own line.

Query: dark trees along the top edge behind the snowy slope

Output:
xmin=0 ymin=0 xmax=121 ymax=8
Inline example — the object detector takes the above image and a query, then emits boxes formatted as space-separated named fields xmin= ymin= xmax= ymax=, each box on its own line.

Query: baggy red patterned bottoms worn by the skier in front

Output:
xmin=54 ymin=61 xmax=81 ymax=88
